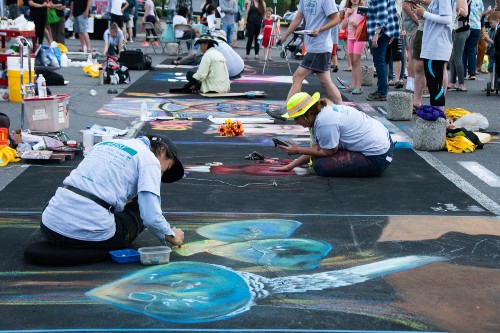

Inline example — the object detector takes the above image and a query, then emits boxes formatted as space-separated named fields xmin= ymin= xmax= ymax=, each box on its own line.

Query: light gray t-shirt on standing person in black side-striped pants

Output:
xmin=420 ymin=0 xmax=456 ymax=61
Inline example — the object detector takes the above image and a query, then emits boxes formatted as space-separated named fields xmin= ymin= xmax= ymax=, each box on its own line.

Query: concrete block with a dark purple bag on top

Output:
xmin=413 ymin=117 xmax=446 ymax=150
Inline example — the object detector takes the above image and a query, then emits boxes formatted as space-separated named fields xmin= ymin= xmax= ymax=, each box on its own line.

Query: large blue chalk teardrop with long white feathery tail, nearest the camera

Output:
xmin=86 ymin=256 xmax=446 ymax=324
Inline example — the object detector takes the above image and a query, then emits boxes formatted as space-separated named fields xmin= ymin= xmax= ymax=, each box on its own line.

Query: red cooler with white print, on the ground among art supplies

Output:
xmin=24 ymin=94 xmax=69 ymax=132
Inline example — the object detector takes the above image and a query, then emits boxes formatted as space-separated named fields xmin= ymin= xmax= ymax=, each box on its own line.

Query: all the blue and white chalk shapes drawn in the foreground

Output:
xmin=87 ymin=219 xmax=446 ymax=323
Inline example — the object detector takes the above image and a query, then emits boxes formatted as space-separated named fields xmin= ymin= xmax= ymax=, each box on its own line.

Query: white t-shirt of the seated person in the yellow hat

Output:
xmin=313 ymin=104 xmax=390 ymax=156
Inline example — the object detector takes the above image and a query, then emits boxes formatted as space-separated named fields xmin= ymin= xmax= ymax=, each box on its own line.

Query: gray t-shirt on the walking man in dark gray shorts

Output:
xmin=298 ymin=0 xmax=338 ymax=53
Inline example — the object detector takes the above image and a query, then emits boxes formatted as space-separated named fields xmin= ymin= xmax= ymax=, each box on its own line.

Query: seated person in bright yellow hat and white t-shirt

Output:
xmin=270 ymin=92 xmax=393 ymax=177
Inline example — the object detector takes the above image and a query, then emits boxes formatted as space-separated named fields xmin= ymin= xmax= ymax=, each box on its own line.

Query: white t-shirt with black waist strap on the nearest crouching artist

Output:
xmin=42 ymin=139 xmax=161 ymax=241
